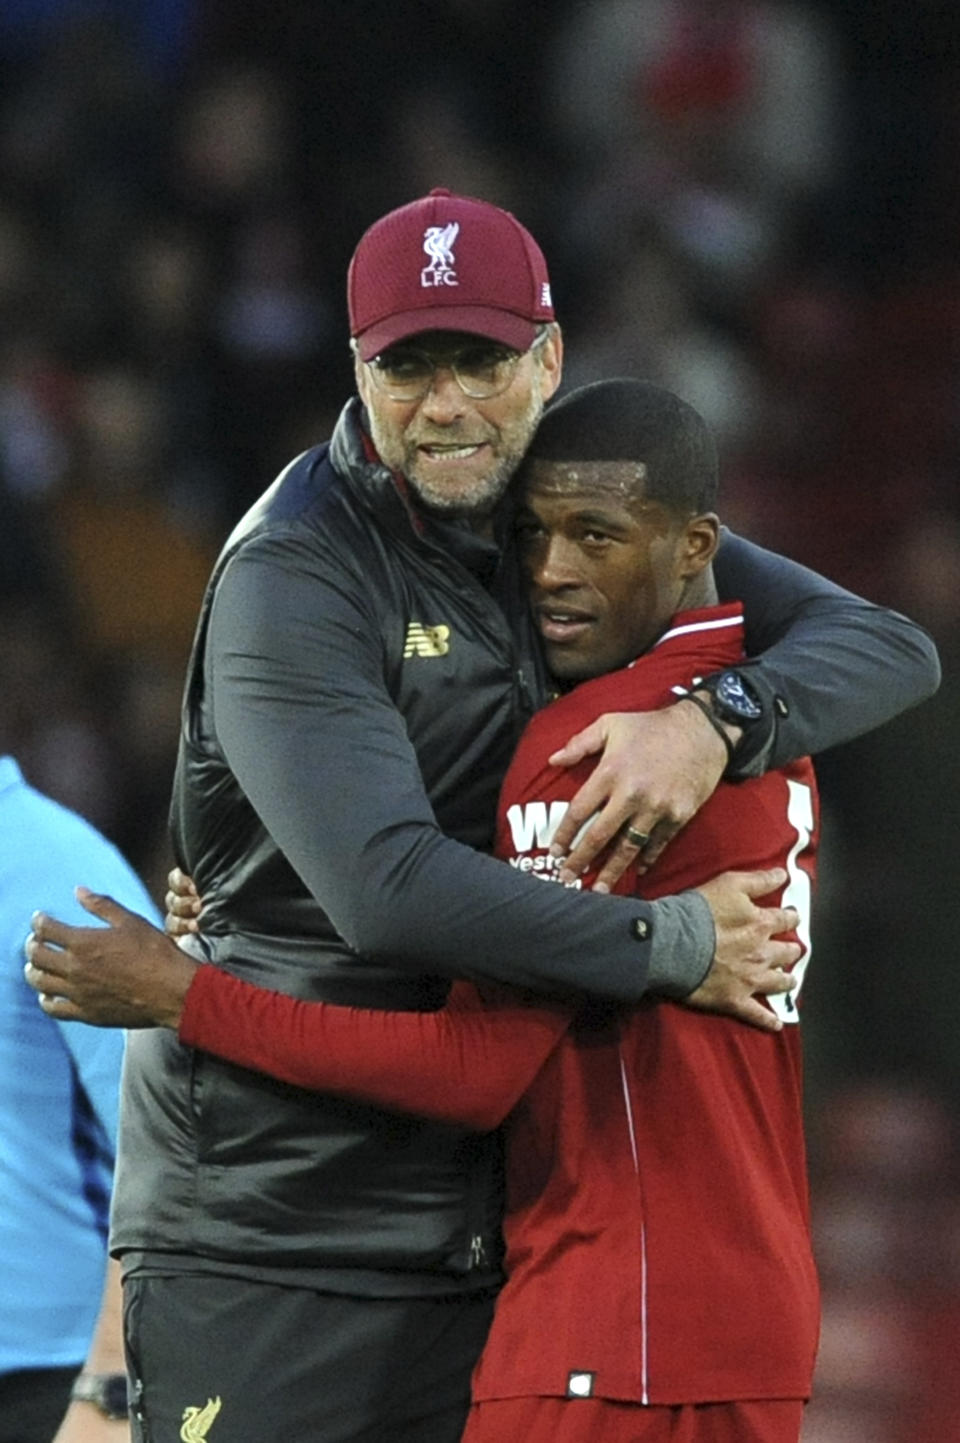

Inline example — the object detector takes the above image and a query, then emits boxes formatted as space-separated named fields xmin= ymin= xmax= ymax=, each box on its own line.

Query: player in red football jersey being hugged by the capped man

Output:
xmin=26 ymin=381 xmax=819 ymax=1443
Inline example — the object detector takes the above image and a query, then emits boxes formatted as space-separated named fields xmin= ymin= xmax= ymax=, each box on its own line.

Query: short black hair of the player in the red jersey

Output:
xmin=527 ymin=378 xmax=719 ymax=514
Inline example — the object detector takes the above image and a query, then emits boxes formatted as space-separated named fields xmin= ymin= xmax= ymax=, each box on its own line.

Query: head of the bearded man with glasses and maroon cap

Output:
xmin=346 ymin=190 xmax=563 ymax=534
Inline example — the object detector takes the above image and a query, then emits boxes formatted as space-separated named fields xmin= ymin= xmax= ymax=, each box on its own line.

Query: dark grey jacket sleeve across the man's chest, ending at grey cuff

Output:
xmin=206 ymin=537 xmax=713 ymax=1001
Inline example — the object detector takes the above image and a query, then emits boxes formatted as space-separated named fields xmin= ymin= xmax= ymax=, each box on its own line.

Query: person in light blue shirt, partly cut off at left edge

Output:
xmin=0 ymin=756 xmax=157 ymax=1443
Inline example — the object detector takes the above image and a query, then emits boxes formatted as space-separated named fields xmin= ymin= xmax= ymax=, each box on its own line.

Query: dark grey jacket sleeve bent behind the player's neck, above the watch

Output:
xmin=715 ymin=531 xmax=940 ymax=778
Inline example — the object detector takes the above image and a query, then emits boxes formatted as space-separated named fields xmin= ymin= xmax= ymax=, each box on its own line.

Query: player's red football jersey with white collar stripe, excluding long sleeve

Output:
xmin=474 ymin=606 xmax=819 ymax=1404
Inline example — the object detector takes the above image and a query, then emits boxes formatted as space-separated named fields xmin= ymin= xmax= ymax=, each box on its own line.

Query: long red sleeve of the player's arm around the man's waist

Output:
xmin=179 ymin=965 xmax=570 ymax=1131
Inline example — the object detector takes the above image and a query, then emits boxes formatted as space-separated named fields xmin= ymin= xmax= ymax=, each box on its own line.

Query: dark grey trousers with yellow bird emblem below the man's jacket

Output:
xmin=124 ymin=1274 xmax=494 ymax=1443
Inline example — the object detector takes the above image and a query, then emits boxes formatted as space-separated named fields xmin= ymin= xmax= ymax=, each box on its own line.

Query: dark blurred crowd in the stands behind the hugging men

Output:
xmin=0 ymin=0 xmax=960 ymax=1443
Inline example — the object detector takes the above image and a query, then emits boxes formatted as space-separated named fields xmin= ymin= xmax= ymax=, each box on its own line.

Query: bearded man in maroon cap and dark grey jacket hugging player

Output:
xmin=22 ymin=190 xmax=937 ymax=1443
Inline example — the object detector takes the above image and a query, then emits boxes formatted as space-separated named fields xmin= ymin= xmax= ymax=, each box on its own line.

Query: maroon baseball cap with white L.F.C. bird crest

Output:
xmin=346 ymin=189 xmax=553 ymax=361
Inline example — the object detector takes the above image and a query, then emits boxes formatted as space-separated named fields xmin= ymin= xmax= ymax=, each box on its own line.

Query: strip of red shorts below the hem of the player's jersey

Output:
xmin=461 ymin=1398 xmax=804 ymax=1443
